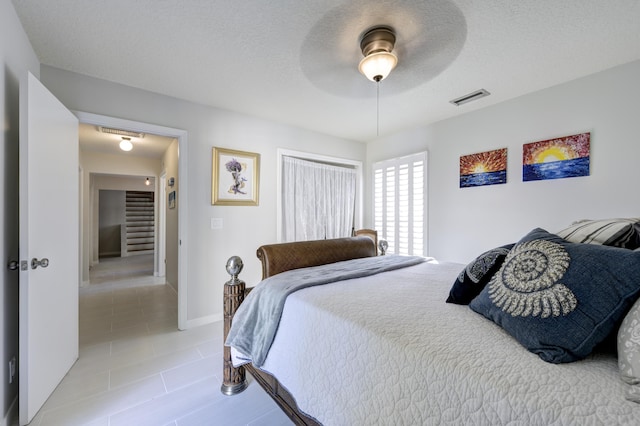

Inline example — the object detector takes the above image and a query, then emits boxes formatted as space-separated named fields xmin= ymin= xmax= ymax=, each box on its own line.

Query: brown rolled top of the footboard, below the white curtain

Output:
xmin=257 ymin=237 xmax=376 ymax=279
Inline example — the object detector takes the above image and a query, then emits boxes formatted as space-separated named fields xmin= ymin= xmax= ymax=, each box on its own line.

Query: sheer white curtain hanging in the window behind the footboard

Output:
xmin=282 ymin=156 xmax=356 ymax=241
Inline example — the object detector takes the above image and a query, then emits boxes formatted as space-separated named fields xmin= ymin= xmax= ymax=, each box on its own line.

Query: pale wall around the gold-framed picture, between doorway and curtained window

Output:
xmin=41 ymin=66 xmax=366 ymax=327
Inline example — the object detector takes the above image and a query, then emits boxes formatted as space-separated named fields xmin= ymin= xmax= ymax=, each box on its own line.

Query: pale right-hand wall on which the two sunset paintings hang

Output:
xmin=365 ymin=59 xmax=640 ymax=262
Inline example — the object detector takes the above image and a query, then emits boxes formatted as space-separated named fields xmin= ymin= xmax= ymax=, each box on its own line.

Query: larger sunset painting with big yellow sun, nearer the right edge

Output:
xmin=522 ymin=133 xmax=591 ymax=182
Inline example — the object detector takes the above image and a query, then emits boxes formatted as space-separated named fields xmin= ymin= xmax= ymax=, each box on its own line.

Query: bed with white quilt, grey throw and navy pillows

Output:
xmin=223 ymin=220 xmax=640 ymax=425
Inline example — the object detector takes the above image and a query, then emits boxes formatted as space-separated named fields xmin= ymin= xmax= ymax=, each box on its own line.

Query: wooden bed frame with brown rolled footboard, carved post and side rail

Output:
xmin=221 ymin=237 xmax=376 ymax=425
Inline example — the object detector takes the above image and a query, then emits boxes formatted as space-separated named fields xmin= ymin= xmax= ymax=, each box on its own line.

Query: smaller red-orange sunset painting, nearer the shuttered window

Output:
xmin=460 ymin=148 xmax=507 ymax=188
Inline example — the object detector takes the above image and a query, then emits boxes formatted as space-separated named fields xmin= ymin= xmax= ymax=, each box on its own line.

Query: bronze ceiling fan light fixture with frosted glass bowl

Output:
xmin=358 ymin=26 xmax=398 ymax=82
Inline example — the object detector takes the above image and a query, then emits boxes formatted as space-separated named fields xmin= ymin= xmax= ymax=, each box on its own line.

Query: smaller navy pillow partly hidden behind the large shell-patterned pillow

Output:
xmin=447 ymin=244 xmax=515 ymax=305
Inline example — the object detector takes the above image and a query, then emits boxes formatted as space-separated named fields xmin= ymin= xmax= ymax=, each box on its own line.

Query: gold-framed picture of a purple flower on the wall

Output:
xmin=211 ymin=147 xmax=260 ymax=206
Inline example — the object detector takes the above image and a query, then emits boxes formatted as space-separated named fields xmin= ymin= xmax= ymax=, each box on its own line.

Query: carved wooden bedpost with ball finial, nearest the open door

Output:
xmin=220 ymin=256 xmax=247 ymax=395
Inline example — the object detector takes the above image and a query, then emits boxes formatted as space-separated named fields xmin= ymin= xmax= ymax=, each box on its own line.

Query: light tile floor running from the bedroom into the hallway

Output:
xmin=31 ymin=255 xmax=292 ymax=426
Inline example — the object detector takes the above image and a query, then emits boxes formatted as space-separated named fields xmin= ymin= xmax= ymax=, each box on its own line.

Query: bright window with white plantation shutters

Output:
xmin=373 ymin=152 xmax=427 ymax=256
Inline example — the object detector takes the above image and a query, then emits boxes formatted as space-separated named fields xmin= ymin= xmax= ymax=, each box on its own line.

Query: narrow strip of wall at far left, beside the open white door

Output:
xmin=0 ymin=0 xmax=40 ymax=426
